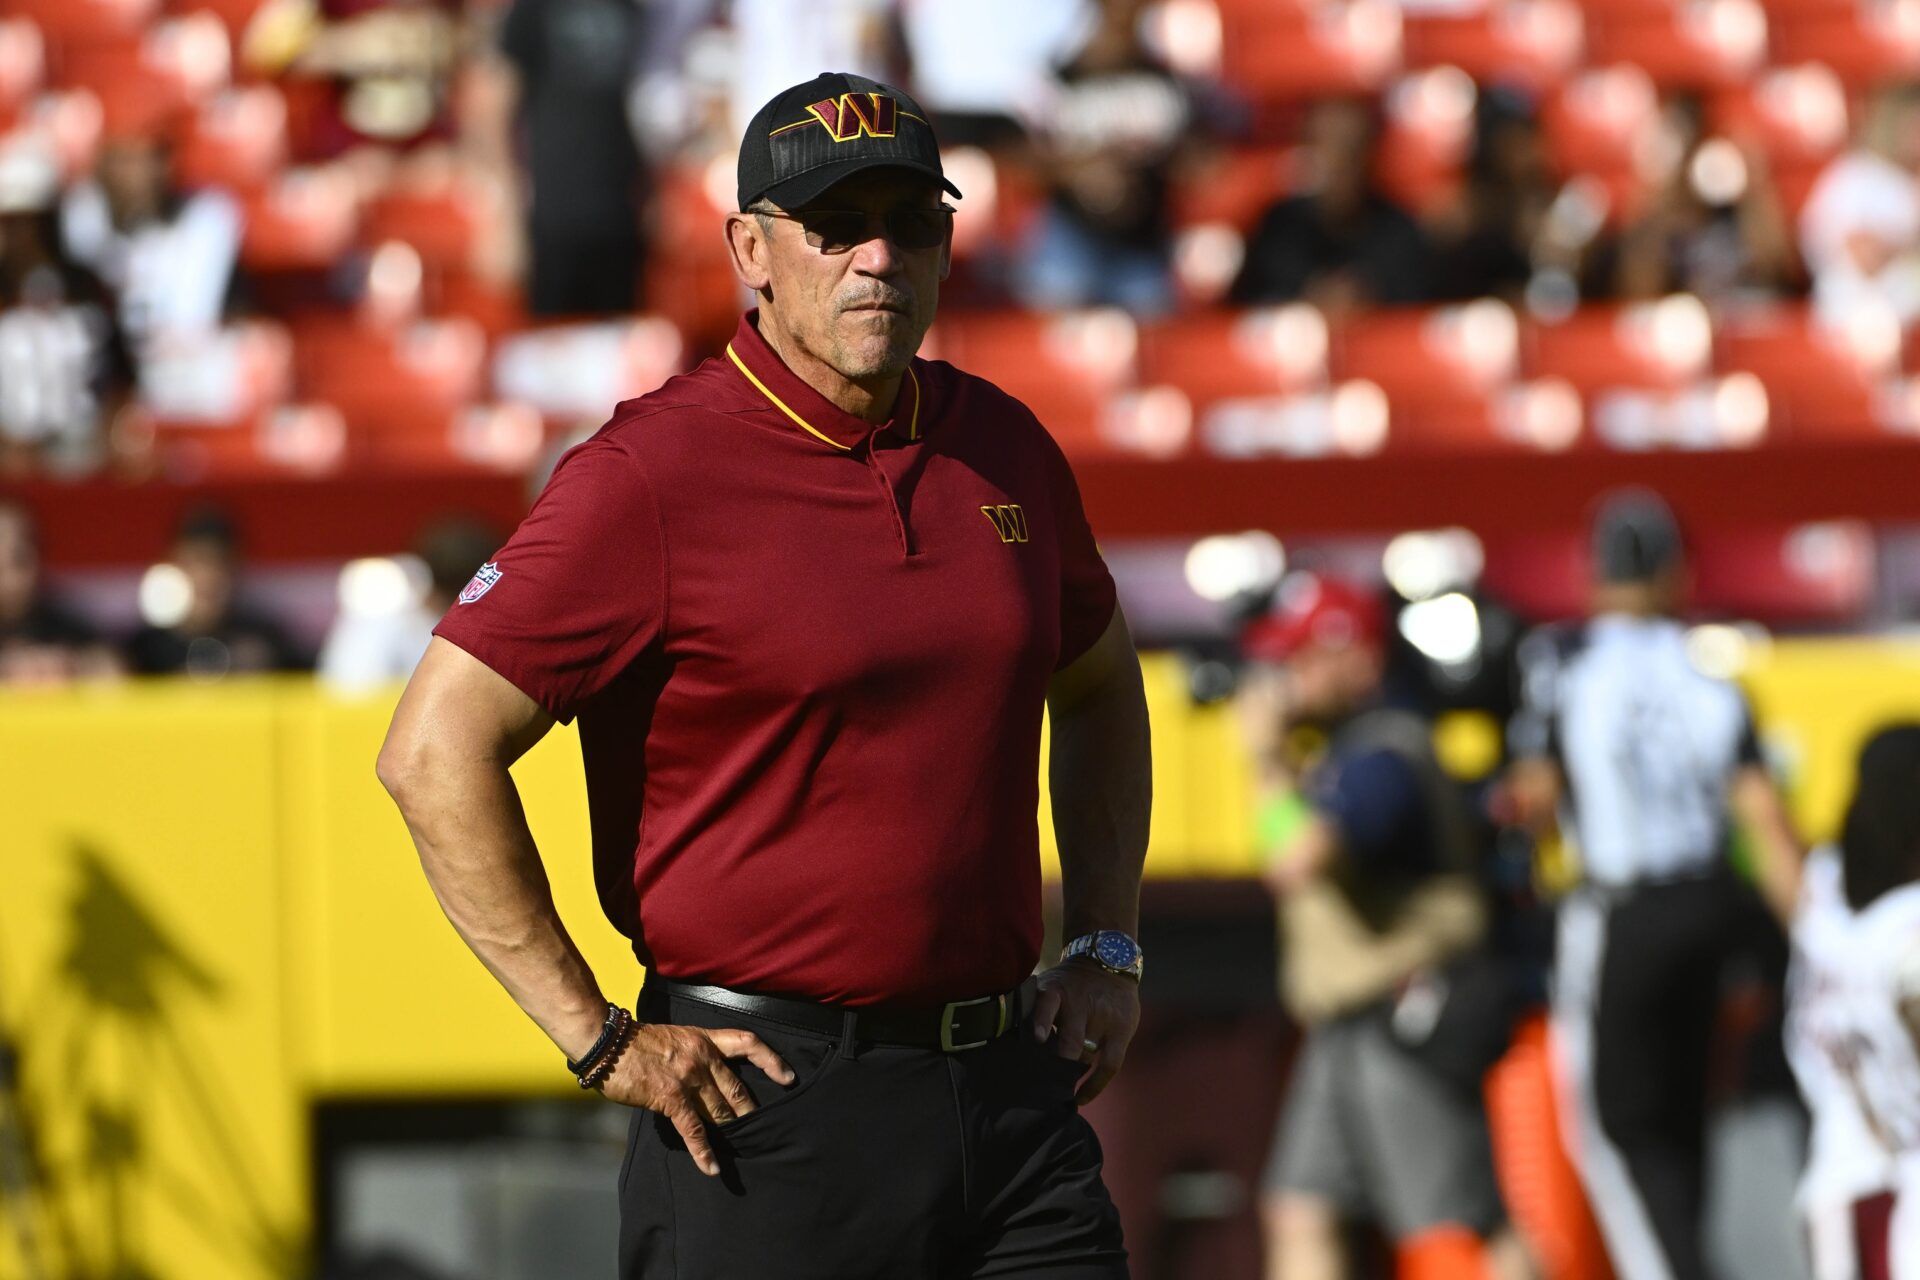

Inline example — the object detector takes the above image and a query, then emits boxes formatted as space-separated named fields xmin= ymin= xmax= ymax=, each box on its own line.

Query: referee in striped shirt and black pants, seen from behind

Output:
xmin=1511 ymin=491 xmax=1799 ymax=1280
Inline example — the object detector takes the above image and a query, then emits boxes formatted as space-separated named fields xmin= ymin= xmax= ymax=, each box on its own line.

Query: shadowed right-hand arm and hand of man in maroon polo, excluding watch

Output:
xmin=1033 ymin=606 xmax=1154 ymax=1103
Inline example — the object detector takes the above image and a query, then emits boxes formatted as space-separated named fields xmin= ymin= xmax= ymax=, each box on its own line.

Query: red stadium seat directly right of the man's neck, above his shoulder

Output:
xmin=935 ymin=309 xmax=1165 ymax=451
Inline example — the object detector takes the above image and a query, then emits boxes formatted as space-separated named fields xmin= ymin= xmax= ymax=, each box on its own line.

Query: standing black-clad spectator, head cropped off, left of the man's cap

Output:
xmin=499 ymin=0 xmax=643 ymax=315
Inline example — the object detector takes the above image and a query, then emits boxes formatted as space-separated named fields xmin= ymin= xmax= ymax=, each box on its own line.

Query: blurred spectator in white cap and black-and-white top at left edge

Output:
xmin=0 ymin=146 xmax=127 ymax=474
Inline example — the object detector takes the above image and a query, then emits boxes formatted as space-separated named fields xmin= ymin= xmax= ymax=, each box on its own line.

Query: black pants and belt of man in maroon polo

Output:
xmin=620 ymin=992 xmax=1127 ymax=1280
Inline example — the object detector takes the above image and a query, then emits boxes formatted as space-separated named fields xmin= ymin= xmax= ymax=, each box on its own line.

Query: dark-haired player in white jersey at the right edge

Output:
xmin=1788 ymin=723 xmax=1920 ymax=1280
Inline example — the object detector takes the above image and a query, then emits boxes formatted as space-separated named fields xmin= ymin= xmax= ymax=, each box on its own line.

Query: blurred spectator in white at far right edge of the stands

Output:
xmin=1799 ymin=84 xmax=1920 ymax=322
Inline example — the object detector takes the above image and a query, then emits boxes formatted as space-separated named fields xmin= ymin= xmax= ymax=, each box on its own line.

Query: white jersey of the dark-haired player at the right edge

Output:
xmin=1788 ymin=848 xmax=1920 ymax=1280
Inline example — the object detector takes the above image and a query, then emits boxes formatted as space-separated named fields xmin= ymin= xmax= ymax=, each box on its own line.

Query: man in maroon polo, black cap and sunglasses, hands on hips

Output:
xmin=380 ymin=75 xmax=1150 ymax=1280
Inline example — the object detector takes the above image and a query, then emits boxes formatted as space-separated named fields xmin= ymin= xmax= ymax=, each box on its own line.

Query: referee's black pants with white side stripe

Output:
xmin=1553 ymin=875 xmax=1749 ymax=1280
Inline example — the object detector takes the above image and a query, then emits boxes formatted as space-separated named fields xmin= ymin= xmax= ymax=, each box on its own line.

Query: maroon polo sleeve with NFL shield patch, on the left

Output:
xmin=434 ymin=439 xmax=668 ymax=722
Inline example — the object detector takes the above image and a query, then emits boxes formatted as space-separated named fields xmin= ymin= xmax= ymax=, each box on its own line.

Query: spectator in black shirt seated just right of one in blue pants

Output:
xmin=1229 ymin=98 xmax=1430 ymax=315
